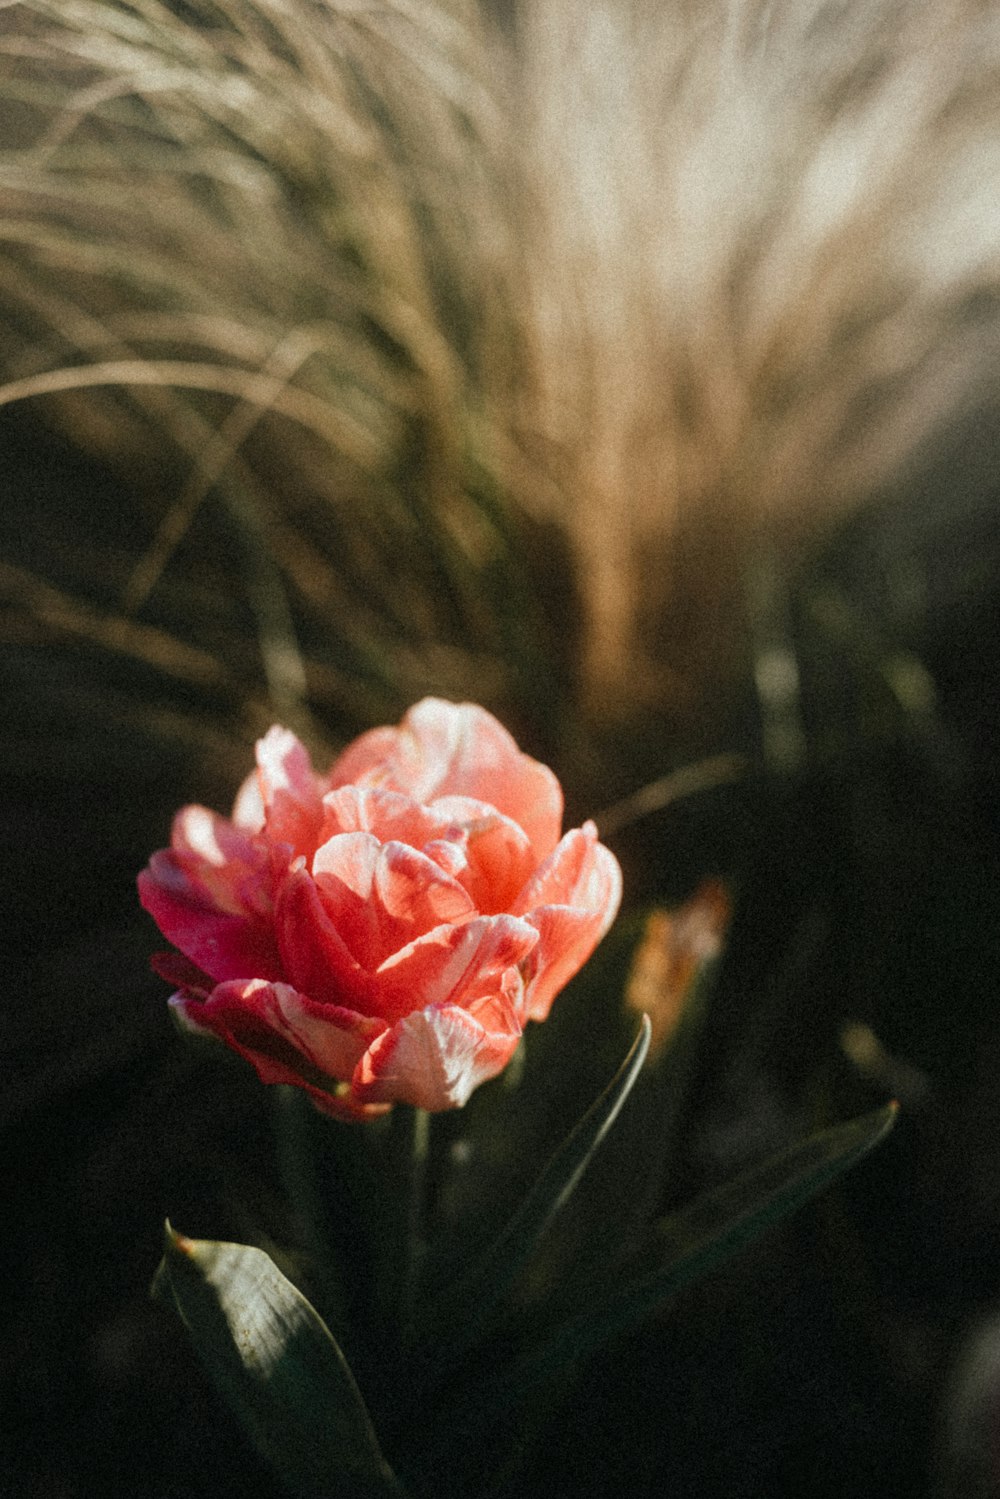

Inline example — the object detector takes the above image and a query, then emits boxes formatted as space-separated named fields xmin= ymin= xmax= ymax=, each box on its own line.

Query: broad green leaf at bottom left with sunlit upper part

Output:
xmin=153 ymin=1223 xmax=402 ymax=1499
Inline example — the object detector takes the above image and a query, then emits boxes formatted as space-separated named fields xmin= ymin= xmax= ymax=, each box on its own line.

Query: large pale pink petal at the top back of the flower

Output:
xmin=330 ymin=697 xmax=562 ymax=860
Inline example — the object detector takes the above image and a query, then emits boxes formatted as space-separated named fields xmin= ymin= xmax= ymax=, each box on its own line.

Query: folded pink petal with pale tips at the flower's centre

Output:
xmin=313 ymin=833 xmax=474 ymax=971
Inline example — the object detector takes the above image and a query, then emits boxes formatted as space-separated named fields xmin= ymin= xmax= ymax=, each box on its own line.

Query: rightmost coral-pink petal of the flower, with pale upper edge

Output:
xmin=514 ymin=823 xmax=622 ymax=1021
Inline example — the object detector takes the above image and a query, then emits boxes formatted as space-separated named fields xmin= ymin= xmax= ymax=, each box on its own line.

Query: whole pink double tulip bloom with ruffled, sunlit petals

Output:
xmin=139 ymin=697 xmax=621 ymax=1118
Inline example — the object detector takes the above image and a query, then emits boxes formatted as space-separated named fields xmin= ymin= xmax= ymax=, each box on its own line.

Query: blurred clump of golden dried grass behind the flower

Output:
xmin=0 ymin=0 xmax=1000 ymax=787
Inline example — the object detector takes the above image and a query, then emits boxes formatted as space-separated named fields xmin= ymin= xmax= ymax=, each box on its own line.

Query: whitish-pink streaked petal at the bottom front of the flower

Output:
xmin=354 ymin=1006 xmax=520 ymax=1112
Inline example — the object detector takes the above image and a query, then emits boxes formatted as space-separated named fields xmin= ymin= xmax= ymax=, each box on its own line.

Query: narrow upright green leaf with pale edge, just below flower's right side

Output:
xmin=413 ymin=1015 xmax=651 ymax=1363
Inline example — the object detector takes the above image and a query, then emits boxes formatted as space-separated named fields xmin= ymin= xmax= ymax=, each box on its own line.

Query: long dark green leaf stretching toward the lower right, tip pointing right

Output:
xmin=477 ymin=1103 xmax=898 ymax=1409
